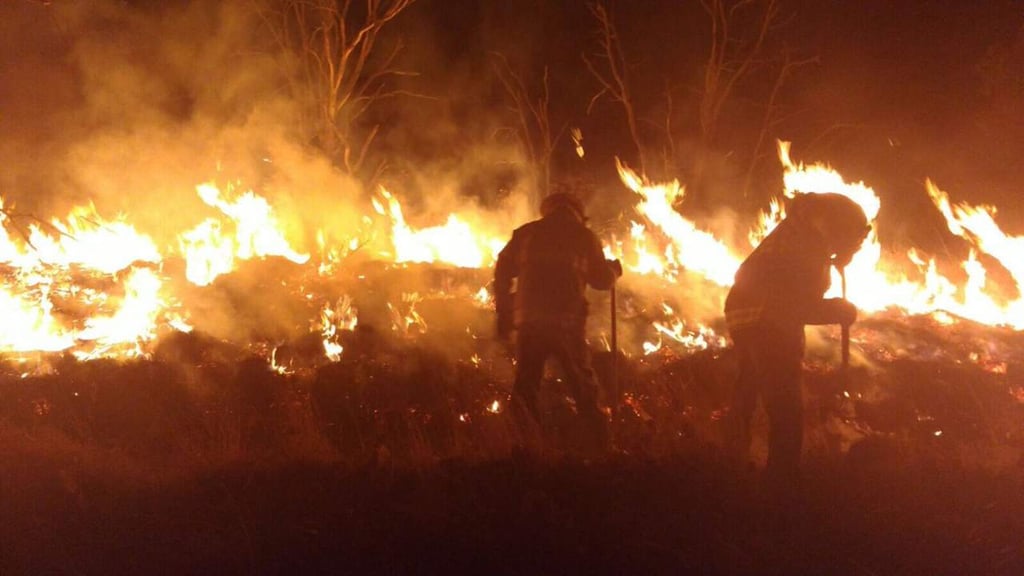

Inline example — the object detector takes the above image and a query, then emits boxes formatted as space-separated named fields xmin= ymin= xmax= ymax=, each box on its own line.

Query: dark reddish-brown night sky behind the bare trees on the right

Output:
xmin=406 ymin=0 xmax=1024 ymax=242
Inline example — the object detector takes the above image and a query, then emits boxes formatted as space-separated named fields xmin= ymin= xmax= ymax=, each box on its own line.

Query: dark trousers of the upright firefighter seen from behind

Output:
xmin=512 ymin=323 xmax=604 ymax=421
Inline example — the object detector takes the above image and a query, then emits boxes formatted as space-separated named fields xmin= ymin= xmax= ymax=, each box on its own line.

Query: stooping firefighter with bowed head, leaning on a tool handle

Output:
xmin=725 ymin=194 xmax=870 ymax=487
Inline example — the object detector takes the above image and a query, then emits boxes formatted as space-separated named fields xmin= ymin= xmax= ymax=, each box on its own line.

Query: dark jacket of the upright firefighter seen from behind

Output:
xmin=495 ymin=207 xmax=615 ymax=333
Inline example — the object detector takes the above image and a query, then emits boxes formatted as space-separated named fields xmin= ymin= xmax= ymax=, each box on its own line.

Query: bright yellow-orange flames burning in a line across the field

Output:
xmin=0 ymin=137 xmax=1024 ymax=364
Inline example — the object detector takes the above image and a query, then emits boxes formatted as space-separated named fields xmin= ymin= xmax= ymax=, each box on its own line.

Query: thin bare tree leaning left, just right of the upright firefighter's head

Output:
xmin=583 ymin=2 xmax=646 ymax=174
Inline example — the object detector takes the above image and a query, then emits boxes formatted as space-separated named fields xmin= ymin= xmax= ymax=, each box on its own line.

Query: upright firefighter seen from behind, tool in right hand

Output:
xmin=494 ymin=192 xmax=623 ymax=447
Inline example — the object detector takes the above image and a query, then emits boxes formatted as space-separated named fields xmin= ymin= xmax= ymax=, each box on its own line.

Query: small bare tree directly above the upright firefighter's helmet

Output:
xmin=494 ymin=53 xmax=565 ymax=199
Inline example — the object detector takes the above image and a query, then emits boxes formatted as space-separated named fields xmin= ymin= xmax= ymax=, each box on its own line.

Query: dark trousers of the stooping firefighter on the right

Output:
xmin=728 ymin=326 xmax=804 ymax=481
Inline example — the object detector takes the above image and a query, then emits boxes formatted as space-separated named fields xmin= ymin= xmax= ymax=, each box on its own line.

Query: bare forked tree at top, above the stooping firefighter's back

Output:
xmin=700 ymin=0 xmax=779 ymax=143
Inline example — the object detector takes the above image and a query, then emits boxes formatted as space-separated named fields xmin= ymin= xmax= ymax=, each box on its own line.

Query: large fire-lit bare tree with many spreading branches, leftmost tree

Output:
xmin=252 ymin=0 xmax=416 ymax=176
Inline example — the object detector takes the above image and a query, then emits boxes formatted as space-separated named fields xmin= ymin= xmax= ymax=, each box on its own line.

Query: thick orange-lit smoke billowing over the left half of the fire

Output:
xmin=0 ymin=0 xmax=548 ymax=348
